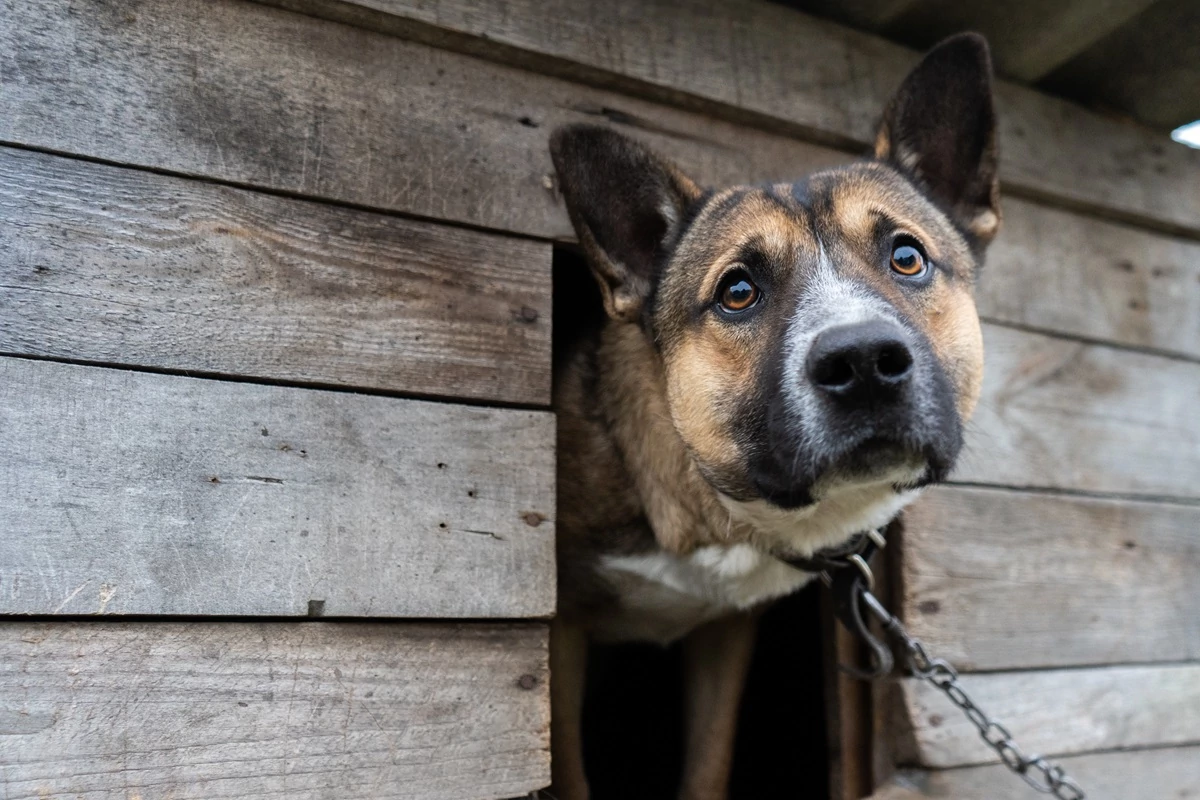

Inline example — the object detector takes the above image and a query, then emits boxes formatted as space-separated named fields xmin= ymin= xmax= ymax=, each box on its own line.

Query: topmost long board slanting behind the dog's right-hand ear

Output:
xmin=267 ymin=0 xmax=1200 ymax=236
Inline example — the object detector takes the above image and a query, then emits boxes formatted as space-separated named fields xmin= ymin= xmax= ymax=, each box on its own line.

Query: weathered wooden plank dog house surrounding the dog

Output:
xmin=0 ymin=0 xmax=1200 ymax=800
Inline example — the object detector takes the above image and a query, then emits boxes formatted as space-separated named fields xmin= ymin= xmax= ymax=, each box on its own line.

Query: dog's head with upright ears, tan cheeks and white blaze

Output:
xmin=551 ymin=35 xmax=1000 ymax=537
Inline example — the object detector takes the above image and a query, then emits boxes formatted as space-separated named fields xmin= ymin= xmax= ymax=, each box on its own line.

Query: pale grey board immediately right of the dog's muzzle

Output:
xmin=954 ymin=325 xmax=1200 ymax=499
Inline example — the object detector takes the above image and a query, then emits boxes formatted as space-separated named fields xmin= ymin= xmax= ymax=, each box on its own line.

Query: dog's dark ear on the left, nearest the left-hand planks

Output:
xmin=550 ymin=125 xmax=700 ymax=321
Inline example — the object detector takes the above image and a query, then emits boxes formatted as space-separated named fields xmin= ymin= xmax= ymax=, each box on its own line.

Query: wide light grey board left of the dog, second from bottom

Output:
xmin=0 ymin=359 xmax=554 ymax=618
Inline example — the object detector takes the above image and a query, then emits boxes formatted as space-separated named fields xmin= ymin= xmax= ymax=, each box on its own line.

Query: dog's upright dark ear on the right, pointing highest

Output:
xmin=875 ymin=34 xmax=1000 ymax=249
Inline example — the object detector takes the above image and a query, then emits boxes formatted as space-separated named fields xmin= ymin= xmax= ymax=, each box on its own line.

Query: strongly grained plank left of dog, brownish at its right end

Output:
xmin=0 ymin=148 xmax=551 ymax=404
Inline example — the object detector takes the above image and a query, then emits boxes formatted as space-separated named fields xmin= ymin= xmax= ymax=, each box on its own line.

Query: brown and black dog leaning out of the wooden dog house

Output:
xmin=551 ymin=35 xmax=1000 ymax=800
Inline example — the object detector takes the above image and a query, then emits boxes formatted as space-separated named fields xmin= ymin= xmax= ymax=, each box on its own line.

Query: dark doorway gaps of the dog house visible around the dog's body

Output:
xmin=553 ymin=248 xmax=829 ymax=800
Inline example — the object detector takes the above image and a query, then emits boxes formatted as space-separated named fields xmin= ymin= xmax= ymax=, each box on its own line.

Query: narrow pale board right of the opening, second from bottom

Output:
xmin=898 ymin=662 xmax=1200 ymax=768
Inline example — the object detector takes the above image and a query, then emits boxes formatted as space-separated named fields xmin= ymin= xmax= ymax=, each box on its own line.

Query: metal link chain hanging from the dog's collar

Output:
xmin=860 ymin=587 xmax=1087 ymax=800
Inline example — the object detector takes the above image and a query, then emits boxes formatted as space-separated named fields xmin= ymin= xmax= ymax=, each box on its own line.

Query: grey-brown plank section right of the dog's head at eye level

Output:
xmin=978 ymin=198 xmax=1200 ymax=359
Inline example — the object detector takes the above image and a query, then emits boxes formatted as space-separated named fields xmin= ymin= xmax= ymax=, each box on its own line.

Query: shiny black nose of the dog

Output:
xmin=805 ymin=320 xmax=913 ymax=402
